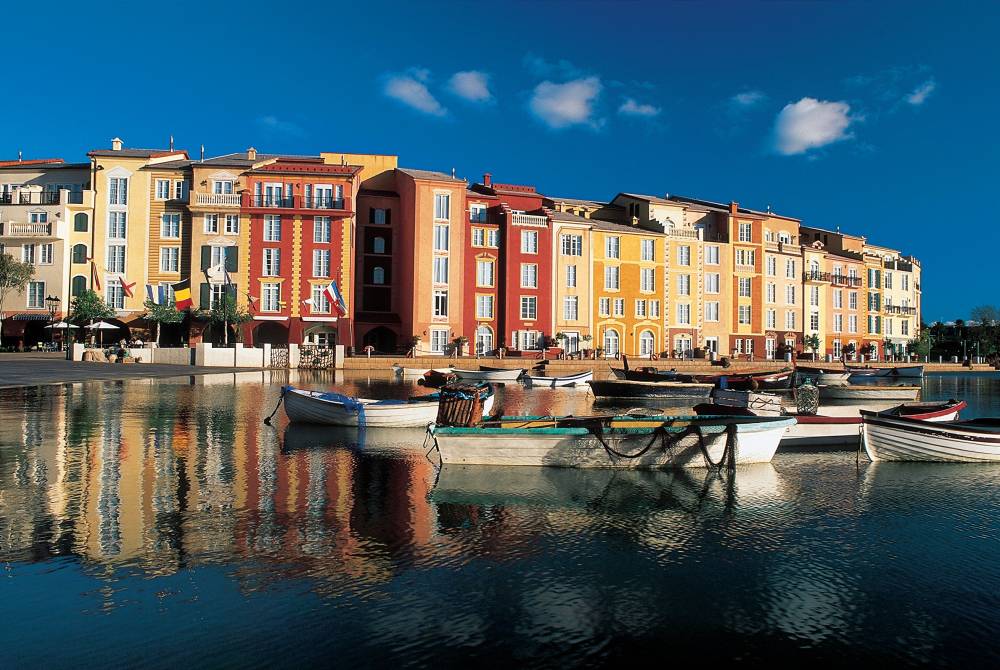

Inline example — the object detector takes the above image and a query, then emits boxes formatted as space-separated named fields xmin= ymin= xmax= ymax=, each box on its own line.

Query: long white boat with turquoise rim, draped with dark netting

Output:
xmin=428 ymin=415 xmax=795 ymax=469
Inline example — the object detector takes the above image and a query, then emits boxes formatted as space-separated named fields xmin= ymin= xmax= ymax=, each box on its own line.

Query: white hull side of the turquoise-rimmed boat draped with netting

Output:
xmin=432 ymin=419 xmax=795 ymax=469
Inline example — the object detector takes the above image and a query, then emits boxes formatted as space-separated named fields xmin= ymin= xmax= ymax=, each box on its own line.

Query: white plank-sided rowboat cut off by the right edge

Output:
xmin=861 ymin=411 xmax=1000 ymax=463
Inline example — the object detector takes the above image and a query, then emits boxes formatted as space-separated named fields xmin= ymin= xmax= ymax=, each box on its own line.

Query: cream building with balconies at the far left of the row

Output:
xmin=0 ymin=158 xmax=93 ymax=345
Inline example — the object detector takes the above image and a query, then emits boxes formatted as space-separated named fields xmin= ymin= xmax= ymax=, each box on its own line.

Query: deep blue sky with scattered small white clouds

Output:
xmin=0 ymin=0 xmax=1000 ymax=322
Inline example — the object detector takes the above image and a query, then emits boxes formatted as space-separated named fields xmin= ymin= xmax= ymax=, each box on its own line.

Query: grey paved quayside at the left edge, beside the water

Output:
xmin=0 ymin=353 xmax=262 ymax=389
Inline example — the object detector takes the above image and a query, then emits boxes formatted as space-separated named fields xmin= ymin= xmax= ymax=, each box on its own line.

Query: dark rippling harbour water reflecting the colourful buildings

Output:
xmin=0 ymin=373 xmax=1000 ymax=668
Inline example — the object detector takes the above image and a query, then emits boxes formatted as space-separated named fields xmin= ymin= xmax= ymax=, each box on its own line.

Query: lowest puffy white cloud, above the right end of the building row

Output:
xmin=774 ymin=98 xmax=855 ymax=156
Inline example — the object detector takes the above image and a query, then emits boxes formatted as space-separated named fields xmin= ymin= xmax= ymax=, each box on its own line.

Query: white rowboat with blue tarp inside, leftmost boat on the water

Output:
xmin=281 ymin=385 xmax=494 ymax=428
